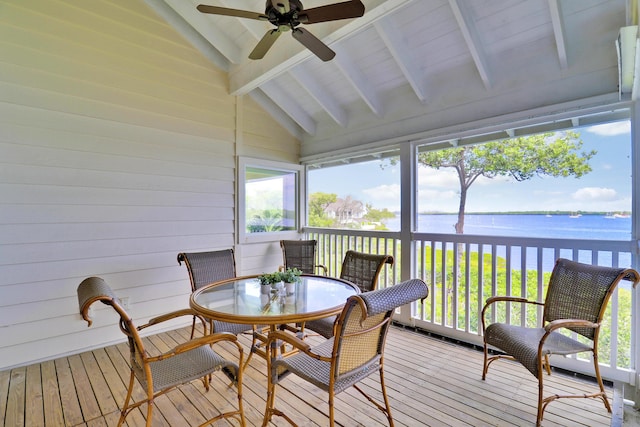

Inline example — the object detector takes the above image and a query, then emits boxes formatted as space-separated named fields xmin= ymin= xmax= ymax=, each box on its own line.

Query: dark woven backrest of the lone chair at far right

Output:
xmin=543 ymin=258 xmax=640 ymax=340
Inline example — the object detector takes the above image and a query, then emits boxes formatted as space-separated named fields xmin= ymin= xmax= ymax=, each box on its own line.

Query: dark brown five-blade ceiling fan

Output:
xmin=197 ymin=0 xmax=364 ymax=61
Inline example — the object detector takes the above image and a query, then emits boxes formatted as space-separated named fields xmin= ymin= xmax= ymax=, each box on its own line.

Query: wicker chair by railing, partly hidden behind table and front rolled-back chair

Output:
xmin=302 ymin=250 xmax=393 ymax=338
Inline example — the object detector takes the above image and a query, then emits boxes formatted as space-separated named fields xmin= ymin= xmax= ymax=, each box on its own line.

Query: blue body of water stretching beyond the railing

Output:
xmin=386 ymin=214 xmax=631 ymax=240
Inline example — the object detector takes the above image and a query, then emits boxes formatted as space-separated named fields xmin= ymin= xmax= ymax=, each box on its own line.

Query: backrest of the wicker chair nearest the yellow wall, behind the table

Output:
xmin=178 ymin=249 xmax=236 ymax=291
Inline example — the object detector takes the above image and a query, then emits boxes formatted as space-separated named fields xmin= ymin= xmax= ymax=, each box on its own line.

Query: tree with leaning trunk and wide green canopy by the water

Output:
xmin=418 ymin=131 xmax=596 ymax=234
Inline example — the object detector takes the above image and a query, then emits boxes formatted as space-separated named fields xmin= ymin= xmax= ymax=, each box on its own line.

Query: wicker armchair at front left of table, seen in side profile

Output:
xmin=78 ymin=277 xmax=246 ymax=427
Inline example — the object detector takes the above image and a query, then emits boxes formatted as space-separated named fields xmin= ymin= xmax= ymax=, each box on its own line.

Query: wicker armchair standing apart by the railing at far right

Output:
xmin=482 ymin=258 xmax=640 ymax=426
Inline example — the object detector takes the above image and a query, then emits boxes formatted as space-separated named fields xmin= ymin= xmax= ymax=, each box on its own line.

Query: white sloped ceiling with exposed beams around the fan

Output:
xmin=146 ymin=0 xmax=634 ymax=161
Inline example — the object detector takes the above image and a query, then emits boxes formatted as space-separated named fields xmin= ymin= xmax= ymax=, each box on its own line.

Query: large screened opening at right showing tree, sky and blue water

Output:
xmin=417 ymin=114 xmax=632 ymax=240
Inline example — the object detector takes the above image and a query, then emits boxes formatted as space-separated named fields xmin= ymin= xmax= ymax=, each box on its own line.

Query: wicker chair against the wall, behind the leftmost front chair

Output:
xmin=178 ymin=249 xmax=253 ymax=337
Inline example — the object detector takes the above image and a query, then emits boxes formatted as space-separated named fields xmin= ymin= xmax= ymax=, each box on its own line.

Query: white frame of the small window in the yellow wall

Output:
xmin=235 ymin=156 xmax=306 ymax=244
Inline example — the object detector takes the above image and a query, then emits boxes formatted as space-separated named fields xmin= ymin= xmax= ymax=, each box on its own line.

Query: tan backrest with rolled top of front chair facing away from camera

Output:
xmin=332 ymin=279 xmax=429 ymax=379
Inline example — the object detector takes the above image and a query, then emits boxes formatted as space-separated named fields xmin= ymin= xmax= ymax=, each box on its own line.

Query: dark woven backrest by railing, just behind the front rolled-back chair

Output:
xmin=340 ymin=250 xmax=393 ymax=292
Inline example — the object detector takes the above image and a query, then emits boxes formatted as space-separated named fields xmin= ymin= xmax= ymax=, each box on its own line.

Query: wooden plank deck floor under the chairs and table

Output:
xmin=0 ymin=327 xmax=627 ymax=427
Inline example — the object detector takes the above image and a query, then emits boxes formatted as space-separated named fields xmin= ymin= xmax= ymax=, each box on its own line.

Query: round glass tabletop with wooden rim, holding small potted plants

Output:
xmin=190 ymin=275 xmax=359 ymax=324
